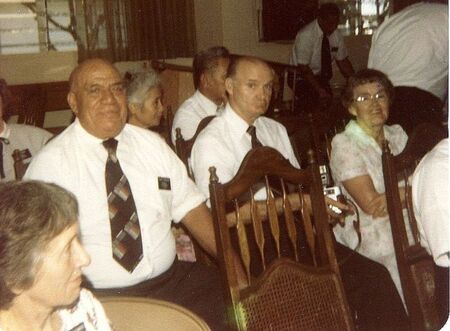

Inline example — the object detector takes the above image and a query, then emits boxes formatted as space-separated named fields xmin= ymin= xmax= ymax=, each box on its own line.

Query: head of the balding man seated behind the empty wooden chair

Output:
xmin=226 ymin=60 xmax=273 ymax=124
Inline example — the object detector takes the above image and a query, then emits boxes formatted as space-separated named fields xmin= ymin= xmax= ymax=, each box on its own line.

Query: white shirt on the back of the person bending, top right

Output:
xmin=367 ymin=3 xmax=448 ymax=100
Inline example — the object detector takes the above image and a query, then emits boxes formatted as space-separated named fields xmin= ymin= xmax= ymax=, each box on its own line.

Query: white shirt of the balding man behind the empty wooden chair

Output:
xmin=191 ymin=104 xmax=300 ymax=201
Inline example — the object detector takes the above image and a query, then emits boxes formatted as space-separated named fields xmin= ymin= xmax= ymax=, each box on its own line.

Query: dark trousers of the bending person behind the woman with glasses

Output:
xmin=387 ymin=86 xmax=444 ymax=135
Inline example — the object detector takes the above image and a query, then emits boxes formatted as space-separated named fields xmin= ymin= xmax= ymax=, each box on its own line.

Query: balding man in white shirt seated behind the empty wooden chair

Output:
xmin=192 ymin=57 xmax=407 ymax=330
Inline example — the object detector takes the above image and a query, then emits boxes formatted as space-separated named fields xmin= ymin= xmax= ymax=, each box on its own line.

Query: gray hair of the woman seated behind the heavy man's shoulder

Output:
xmin=127 ymin=70 xmax=161 ymax=105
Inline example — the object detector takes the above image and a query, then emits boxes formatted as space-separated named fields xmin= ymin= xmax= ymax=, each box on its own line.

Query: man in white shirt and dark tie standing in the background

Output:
xmin=289 ymin=3 xmax=354 ymax=111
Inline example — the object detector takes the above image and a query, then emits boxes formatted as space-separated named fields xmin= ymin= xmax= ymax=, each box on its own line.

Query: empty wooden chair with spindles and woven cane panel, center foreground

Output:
xmin=210 ymin=147 xmax=353 ymax=330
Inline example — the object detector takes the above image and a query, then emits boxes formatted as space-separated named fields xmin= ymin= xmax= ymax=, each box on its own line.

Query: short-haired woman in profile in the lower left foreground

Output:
xmin=0 ymin=181 xmax=111 ymax=331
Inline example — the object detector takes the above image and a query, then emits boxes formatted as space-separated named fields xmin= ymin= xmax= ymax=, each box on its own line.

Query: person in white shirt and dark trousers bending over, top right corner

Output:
xmin=367 ymin=2 xmax=448 ymax=133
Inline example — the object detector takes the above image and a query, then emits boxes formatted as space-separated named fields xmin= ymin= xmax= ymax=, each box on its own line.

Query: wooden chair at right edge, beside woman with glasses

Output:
xmin=382 ymin=123 xmax=445 ymax=330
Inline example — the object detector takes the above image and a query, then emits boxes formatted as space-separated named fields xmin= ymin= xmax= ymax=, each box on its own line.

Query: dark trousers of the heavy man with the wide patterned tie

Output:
xmin=90 ymin=260 xmax=228 ymax=331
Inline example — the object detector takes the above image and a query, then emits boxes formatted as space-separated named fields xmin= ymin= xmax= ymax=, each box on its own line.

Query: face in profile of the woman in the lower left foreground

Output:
xmin=19 ymin=223 xmax=90 ymax=310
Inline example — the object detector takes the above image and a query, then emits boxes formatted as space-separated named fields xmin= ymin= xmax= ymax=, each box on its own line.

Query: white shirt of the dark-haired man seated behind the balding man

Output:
xmin=172 ymin=90 xmax=221 ymax=145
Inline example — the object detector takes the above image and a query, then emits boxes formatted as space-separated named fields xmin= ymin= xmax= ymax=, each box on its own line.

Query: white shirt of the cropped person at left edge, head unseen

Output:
xmin=0 ymin=123 xmax=52 ymax=181
